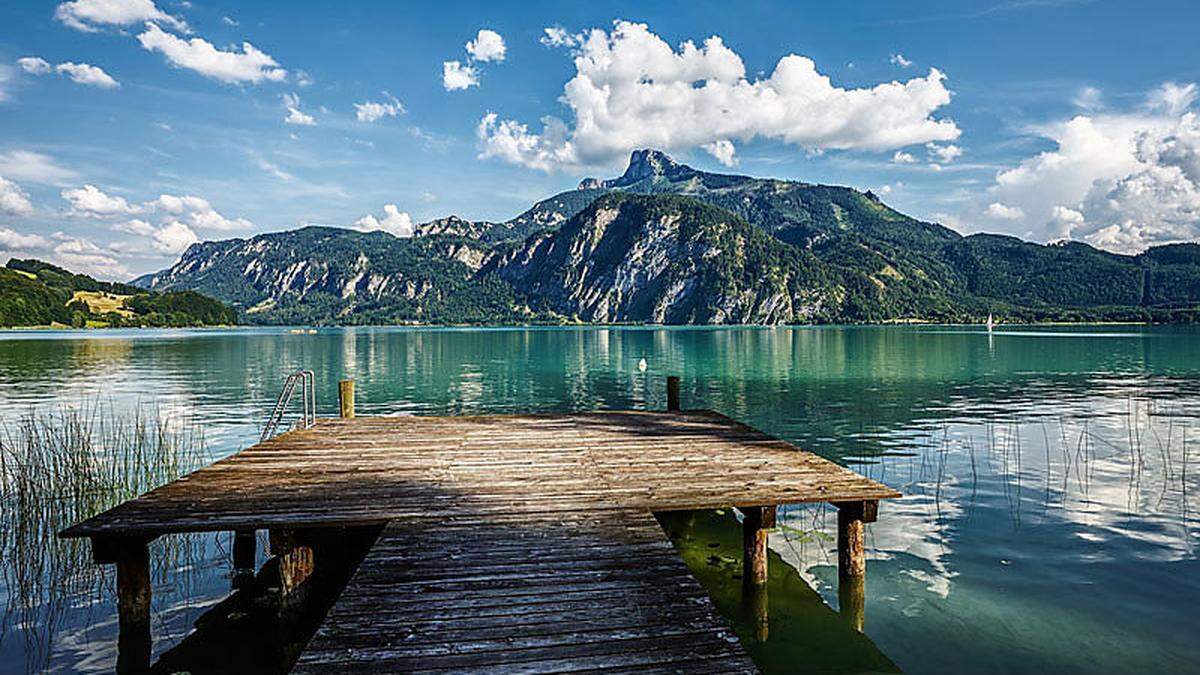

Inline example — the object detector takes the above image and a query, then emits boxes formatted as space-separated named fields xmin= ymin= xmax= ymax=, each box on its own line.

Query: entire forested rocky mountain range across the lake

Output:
xmin=134 ymin=150 xmax=1200 ymax=324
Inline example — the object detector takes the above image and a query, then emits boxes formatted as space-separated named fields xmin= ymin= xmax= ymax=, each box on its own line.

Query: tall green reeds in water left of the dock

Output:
xmin=0 ymin=401 xmax=205 ymax=670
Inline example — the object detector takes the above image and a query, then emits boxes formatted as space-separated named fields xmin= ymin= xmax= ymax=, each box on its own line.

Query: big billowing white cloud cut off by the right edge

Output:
xmin=989 ymin=83 xmax=1200 ymax=252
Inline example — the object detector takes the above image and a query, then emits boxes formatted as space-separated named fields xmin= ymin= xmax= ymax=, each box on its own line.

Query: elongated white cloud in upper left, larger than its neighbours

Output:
xmin=138 ymin=23 xmax=288 ymax=84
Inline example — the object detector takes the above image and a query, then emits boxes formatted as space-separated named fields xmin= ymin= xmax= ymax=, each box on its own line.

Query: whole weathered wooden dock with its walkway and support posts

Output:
xmin=62 ymin=381 xmax=899 ymax=673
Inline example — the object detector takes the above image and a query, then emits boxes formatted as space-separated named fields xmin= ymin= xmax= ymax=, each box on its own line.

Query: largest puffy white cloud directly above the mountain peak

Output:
xmin=479 ymin=22 xmax=960 ymax=171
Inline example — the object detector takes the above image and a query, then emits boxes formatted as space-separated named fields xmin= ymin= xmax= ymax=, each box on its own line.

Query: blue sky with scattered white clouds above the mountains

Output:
xmin=0 ymin=0 xmax=1200 ymax=279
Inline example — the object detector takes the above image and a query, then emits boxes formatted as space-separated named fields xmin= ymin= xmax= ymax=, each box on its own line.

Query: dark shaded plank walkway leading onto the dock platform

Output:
xmin=296 ymin=510 xmax=752 ymax=673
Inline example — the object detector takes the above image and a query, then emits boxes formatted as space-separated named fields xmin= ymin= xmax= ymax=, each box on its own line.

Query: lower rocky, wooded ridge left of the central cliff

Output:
xmin=133 ymin=219 xmax=538 ymax=323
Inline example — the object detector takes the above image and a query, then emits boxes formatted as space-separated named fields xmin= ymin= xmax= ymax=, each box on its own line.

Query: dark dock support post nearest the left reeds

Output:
xmin=91 ymin=537 xmax=151 ymax=674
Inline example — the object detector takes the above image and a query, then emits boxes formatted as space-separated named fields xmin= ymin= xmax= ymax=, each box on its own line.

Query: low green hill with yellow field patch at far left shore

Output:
xmin=0 ymin=258 xmax=238 ymax=328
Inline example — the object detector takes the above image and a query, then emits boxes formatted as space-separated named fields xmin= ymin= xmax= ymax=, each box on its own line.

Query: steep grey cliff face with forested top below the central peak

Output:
xmin=484 ymin=193 xmax=836 ymax=324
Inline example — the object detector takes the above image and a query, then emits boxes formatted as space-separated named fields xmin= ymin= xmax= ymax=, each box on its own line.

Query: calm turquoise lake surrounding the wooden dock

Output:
xmin=0 ymin=325 xmax=1200 ymax=673
